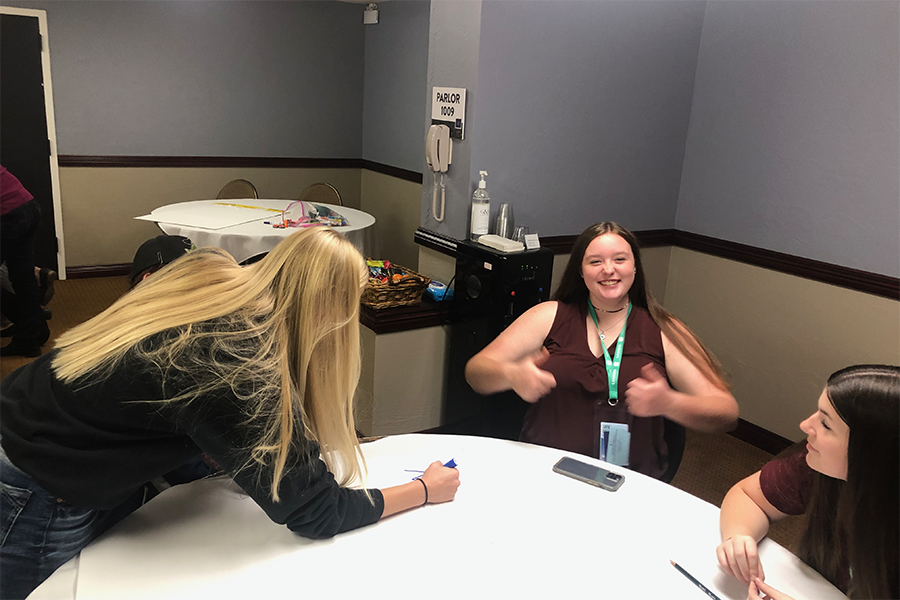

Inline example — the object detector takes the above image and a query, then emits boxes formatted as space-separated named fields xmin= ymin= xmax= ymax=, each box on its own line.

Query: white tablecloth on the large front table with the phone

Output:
xmin=31 ymin=435 xmax=844 ymax=600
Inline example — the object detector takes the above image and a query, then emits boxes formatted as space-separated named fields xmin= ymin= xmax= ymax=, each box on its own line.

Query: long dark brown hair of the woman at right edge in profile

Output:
xmin=797 ymin=365 xmax=900 ymax=600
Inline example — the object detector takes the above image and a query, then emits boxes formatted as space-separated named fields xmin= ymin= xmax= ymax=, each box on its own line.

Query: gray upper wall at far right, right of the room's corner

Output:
xmin=676 ymin=0 xmax=900 ymax=277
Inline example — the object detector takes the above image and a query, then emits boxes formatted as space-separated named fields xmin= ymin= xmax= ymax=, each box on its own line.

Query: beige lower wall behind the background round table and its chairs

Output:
xmin=59 ymin=167 xmax=362 ymax=267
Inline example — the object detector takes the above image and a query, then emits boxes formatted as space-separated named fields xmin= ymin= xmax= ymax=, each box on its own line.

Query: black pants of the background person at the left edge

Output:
xmin=0 ymin=200 xmax=50 ymax=356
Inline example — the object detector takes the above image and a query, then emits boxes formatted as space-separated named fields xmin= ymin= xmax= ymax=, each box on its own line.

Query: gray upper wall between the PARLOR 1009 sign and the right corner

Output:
xmin=423 ymin=0 xmax=705 ymax=237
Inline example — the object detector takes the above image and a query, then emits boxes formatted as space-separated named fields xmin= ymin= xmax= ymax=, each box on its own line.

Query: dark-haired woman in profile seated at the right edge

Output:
xmin=716 ymin=365 xmax=900 ymax=600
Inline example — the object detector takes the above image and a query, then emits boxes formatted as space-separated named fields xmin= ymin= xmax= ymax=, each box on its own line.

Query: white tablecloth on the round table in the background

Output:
xmin=137 ymin=199 xmax=378 ymax=262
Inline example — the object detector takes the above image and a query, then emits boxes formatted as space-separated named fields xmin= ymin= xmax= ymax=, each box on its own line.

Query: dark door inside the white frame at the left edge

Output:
xmin=0 ymin=14 xmax=59 ymax=271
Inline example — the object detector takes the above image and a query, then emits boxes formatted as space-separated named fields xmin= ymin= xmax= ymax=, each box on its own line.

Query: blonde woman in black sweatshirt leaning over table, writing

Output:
xmin=0 ymin=227 xmax=459 ymax=600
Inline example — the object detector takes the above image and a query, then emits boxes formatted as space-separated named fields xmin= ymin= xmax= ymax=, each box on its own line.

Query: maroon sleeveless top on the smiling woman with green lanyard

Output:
xmin=519 ymin=302 xmax=668 ymax=478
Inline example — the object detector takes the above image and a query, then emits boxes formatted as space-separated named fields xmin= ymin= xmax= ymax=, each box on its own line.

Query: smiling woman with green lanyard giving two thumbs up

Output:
xmin=466 ymin=223 xmax=738 ymax=478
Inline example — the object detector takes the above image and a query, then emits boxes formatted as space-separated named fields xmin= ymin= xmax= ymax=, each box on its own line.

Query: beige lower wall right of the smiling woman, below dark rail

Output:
xmin=666 ymin=248 xmax=900 ymax=440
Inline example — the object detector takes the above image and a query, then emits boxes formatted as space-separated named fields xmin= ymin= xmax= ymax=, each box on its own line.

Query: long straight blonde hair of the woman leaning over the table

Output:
xmin=53 ymin=227 xmax=366 ymax=501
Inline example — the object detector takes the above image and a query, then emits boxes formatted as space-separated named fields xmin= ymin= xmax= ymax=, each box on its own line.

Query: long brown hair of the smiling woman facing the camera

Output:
xmin=553 ymin=221 xmax=728 ymax=390
